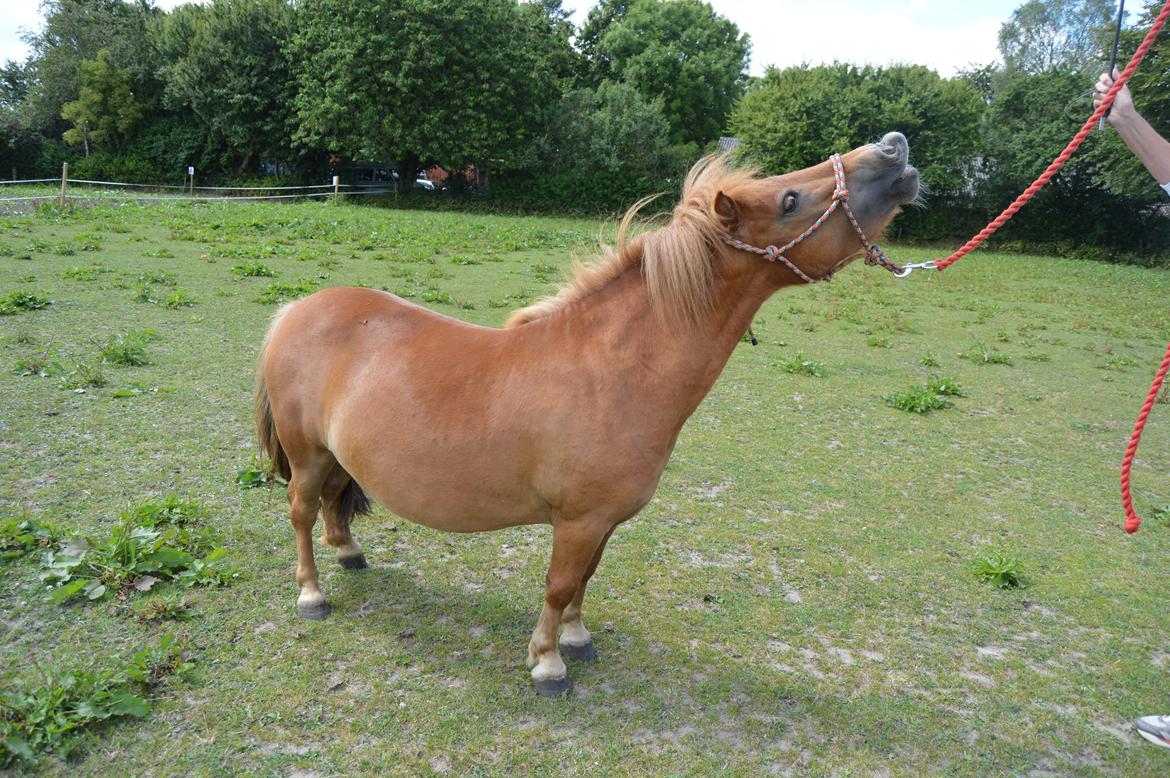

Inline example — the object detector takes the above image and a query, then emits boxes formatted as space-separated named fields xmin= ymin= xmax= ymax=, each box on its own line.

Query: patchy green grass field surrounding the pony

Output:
xmin=0 ymin=197 xmax=1170 ymax=777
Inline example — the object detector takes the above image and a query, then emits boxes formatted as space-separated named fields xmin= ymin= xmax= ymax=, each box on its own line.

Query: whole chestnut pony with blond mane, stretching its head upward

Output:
xmin=256 ymin=133 xmax=918 ymax=695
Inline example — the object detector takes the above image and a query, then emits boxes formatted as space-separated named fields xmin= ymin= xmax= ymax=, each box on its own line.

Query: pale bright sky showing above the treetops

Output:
xmin=0 ymin=0 xmax=1076 ymax=76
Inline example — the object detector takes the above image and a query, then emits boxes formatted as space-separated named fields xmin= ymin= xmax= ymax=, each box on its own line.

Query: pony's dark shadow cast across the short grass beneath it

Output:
xmin=304 ymin=559 xmax=965 ymax=769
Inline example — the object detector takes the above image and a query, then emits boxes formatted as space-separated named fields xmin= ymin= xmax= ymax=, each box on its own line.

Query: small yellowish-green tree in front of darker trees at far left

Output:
xmin=61 ymin=49 xmax=142 ymax=157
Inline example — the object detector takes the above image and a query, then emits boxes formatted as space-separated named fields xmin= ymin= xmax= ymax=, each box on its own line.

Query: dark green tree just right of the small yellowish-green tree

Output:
xmin=156 ymin=0 xmax=296 ymax=173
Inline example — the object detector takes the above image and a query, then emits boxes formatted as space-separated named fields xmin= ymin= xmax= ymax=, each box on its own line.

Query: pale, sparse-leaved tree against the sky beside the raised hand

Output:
xmin=999 ymin=0 xmax=1116 ymax=73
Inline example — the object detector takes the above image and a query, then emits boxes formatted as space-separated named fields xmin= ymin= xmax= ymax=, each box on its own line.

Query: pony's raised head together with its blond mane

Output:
xmin=508 ymin=132 xmax=918 ymax=326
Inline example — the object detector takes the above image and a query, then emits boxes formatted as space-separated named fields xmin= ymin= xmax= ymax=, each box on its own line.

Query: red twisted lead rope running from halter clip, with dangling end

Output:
xmin=935 ymin=0 xmax=1170 ymax=535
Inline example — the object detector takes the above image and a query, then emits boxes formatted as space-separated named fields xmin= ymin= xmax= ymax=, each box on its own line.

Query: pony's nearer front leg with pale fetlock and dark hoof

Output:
xmin=528 ymin=517 xmax=611 ymax=697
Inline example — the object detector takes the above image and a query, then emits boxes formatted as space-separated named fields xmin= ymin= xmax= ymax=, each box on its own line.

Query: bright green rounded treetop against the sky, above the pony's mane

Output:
xmin=581 ymin=0 xmax=751 ymax=145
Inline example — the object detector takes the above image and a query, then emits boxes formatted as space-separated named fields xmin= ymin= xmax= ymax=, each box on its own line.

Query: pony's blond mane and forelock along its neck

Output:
xmin=505 ymin=154 xmax=756 ymax=328
